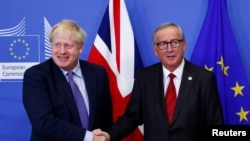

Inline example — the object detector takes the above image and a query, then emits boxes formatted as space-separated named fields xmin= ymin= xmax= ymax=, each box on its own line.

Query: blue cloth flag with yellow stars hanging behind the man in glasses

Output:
xmin=190 ymin=0 xmax=250 ymax=125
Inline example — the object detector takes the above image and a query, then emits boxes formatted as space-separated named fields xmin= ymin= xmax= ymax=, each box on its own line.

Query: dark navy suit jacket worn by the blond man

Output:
xmin=23 ymin=59 xmax=112 ymax=141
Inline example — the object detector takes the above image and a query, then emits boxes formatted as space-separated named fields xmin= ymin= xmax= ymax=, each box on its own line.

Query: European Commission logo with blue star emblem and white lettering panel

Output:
xmin=0 ymin=19 xmax=40 ymax=81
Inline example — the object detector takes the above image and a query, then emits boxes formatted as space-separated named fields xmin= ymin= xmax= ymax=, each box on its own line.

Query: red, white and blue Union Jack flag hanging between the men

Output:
xmin=88 ymin=0 xmax=143 ymax=141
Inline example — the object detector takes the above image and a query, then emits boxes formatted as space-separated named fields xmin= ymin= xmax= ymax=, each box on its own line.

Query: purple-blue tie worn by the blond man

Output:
xmin=67 ymin=71 xmax=88 ymax=129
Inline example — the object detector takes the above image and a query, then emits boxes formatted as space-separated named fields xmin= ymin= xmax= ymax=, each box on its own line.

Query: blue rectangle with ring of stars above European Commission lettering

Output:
xmin=0 ymin=36 xmax=40 ymax=62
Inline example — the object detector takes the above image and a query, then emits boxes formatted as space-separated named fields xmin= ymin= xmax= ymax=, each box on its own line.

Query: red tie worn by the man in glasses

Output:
xmin=165 ymin=73 xmax=176 ymax=124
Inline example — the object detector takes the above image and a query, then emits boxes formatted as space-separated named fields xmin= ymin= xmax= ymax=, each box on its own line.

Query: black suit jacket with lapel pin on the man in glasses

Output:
xmin=107 ymin=60 xmax=224 ymax=141
